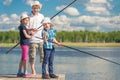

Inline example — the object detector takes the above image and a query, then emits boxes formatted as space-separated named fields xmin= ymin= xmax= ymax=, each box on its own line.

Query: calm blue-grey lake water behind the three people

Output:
xmin=0 ymin=47 xmax=120 ymax=80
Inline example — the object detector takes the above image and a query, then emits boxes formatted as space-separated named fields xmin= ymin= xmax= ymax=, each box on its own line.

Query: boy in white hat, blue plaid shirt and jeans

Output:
xmin=42 ymin=18 xmax=62 ymax=79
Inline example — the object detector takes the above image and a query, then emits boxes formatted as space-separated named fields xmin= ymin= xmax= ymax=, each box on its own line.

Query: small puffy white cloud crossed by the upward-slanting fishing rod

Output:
xmin=56 ymin=5 xmax=80 ymax=16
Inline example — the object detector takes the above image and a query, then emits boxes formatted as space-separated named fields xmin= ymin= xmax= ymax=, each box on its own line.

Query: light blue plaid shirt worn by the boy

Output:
xmin=43 ymin=28 xmax=56 ymax=49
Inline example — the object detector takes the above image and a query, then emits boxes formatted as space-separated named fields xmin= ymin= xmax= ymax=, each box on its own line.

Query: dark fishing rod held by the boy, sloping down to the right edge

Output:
xmin=36 ymin=37 xmax=120 ymax=65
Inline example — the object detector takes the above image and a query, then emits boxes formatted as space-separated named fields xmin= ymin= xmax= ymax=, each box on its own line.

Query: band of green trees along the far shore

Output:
xmin=0 ymin=30 xmax=120 ymax=43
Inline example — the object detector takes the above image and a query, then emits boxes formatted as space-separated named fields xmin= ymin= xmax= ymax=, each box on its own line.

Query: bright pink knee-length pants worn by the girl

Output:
xmin=20 ymin=45 xmax=29 ymax=61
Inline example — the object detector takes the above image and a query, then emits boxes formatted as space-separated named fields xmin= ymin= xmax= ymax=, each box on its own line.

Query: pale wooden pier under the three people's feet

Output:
xmin=0 ymin=74 xmax=65 ymax=80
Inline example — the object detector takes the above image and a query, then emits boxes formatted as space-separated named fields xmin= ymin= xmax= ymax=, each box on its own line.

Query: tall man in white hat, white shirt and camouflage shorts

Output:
xmin=28 ymin=1 xmax=44 ymax=75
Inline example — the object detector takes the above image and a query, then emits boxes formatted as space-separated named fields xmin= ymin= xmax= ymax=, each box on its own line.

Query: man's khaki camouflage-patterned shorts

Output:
xmin=29 ymin=42 xmax=44 ymax=63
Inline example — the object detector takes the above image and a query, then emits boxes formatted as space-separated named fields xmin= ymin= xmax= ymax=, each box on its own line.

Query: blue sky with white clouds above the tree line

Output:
xmin=0 ymin=0 xmax=120 ymax=32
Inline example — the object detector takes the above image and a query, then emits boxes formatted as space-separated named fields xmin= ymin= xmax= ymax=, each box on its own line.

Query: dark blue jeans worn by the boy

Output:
xmin=42 ymin=47 xmax=55 ymax=75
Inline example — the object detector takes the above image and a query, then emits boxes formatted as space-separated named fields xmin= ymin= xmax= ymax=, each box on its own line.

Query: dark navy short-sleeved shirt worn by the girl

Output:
xmin=19 ymin=24 xmax=29 ymax=45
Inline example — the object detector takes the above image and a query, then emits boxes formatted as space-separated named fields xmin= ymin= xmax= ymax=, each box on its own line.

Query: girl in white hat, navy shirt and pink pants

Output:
xmin=17 ymin=14 xmax=31 ymax=77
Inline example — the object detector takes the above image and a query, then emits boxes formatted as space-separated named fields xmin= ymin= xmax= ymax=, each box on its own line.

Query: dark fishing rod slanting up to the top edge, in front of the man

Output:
xmin=6 ymin=0 xmax=77 ymax=54
